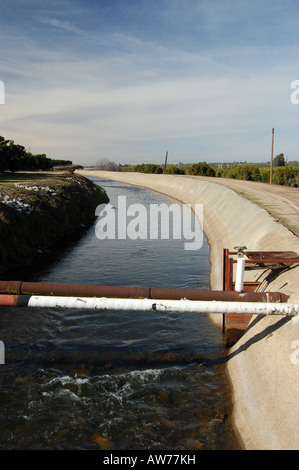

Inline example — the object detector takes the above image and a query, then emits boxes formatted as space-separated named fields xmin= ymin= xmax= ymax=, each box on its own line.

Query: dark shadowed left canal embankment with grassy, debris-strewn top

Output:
xmin=0 ymin=172 xmax=108 ymax=273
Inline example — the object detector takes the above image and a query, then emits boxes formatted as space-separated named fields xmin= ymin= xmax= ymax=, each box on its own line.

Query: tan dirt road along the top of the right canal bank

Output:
xmin=195 ymin=176 xmax=299 ymax=237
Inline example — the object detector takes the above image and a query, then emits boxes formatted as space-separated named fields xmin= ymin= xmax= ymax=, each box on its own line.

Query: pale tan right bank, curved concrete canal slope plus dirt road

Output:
xmin=81 ymin=171 xmax=299 ymax=449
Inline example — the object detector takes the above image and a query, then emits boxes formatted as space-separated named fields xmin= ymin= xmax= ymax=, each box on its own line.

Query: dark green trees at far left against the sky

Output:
xmin=0 ymin=136 xmax=72 ymax=173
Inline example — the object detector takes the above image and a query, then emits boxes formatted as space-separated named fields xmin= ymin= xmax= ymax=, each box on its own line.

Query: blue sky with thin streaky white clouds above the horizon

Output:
xmin=0 ymin=0 xmax=299 ymax=165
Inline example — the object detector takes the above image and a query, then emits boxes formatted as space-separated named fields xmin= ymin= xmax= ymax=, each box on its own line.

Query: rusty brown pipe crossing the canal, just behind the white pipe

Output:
xmin=0 ymin=281 xmax=288 ymax=302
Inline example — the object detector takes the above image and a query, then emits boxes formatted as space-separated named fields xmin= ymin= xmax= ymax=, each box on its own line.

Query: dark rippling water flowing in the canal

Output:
xmin=0 ymin=178 xmax=238 ymax=451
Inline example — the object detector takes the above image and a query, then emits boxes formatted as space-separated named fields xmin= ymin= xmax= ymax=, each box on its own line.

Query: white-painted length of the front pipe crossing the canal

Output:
xmin=27 ymin=295 xmax=299 ymax=316
